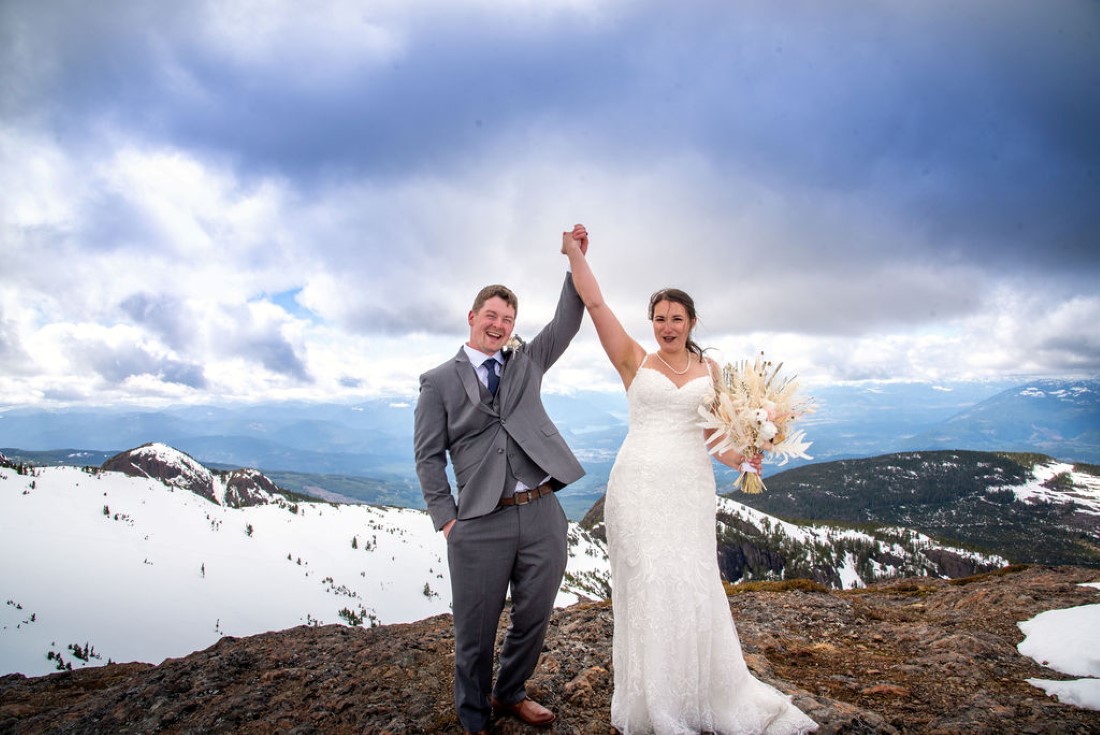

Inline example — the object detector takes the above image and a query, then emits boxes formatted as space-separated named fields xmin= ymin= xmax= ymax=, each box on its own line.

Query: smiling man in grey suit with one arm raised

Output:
xmin=414 ymin=224 xmax=589 ymax=733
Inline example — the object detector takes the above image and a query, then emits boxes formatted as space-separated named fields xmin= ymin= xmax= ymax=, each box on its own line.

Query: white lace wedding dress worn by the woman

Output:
xmin=604 ymin=366 xmax=816 ymax=735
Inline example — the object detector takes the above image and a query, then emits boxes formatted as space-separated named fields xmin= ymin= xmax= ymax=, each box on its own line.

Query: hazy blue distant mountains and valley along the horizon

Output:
xmin=0 ymin=381 xmax=1100 ymax=519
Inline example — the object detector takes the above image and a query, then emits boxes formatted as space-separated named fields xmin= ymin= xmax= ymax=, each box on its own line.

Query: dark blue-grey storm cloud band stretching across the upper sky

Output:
xmin=8 ymin=0 xmax=1100 ymax=278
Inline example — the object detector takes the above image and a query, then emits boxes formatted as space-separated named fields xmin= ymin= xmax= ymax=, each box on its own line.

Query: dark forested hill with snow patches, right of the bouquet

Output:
xmin=736 ymin=450 xmax=1100 ymax=567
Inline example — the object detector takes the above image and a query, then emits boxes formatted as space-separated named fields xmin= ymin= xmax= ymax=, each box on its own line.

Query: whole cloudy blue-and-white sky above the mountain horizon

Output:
xmin=0 ymin=0 xmax=1100 ymax=406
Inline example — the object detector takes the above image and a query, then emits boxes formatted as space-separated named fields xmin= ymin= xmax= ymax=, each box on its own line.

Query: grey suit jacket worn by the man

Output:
xmin=413 ymin=275 xmax=584 ymax=528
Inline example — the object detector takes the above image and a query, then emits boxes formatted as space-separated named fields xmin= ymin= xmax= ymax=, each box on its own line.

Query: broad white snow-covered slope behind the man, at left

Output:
xmin=0 ymin=445 xmax=609 ymax=676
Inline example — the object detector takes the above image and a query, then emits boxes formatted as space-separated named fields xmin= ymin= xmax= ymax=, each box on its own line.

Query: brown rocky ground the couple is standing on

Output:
xmin=0 ymin=567 xmax=1100 ymax=735
